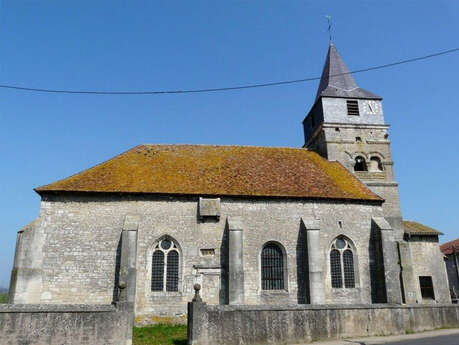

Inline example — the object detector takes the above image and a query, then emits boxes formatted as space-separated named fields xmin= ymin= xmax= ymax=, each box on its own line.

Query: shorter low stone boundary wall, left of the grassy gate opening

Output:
xmin=0 ymin=302 xmax=133 ymax=345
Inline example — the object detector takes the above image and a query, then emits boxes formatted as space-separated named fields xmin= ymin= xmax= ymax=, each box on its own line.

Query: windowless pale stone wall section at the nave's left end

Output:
xmin=40 ymin=196 xmax=126 ymax=304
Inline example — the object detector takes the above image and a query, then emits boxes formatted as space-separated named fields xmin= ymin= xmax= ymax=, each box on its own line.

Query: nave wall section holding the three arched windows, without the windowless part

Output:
xmin=136 ymin=198 xmax=382 ymax=321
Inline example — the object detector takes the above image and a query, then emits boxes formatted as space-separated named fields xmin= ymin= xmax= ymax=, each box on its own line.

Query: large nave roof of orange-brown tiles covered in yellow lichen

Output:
xmin=35 ymin=145 xmax=383 ymax=202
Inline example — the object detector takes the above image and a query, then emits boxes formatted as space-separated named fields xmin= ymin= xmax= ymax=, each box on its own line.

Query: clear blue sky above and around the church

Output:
xmin=0 ymin=0 xmax=459 ymax=286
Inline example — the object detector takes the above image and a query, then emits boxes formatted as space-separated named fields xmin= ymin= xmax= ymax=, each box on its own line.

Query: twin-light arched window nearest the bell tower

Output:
xmin=330 ymin=236 xmax=355 ymax=289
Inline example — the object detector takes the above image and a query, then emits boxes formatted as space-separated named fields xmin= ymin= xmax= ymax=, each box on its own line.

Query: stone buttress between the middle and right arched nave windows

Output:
xmin=302 ymin=218 xmax=325 ymax=304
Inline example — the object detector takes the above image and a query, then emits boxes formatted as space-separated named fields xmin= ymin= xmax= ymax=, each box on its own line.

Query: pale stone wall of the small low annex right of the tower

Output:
xmin=409 ymin=239 xmax=451 ymax=303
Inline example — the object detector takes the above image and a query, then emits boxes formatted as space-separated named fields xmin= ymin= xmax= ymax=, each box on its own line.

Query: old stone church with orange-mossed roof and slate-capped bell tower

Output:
xmin=10 ymin=44 xmax=450 ymax=322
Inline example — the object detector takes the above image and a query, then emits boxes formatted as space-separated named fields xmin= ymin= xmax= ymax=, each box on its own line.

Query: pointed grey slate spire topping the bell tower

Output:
xmin=316 ymin=42 xmax=382 ymax=99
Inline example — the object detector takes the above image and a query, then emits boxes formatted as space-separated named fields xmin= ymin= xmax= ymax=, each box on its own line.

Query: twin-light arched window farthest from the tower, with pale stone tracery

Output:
xmin=151 ymin=238 xmax=180 ymax=291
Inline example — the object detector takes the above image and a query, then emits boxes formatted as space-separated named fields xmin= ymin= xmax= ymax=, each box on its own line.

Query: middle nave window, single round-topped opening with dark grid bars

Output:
xmin=261 ymin=243 xmax=285 ymax=290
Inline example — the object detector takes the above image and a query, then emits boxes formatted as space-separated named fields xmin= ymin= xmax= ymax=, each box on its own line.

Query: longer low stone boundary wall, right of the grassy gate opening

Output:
xmin=188 ymin=302 xmax=459 ymax=345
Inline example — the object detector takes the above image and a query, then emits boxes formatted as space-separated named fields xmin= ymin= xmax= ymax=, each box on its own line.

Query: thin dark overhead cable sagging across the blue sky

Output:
xmin=0 ymin=48 xmax=459 ymax=95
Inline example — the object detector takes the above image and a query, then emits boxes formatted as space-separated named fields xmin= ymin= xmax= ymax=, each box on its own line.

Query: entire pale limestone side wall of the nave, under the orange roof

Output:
xmin=12 ymin=195 xmax=382 ymax=322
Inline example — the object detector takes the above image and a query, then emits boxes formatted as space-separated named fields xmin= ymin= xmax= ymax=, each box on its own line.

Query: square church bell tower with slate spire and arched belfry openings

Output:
xmin=303 ymin=43 xmax=403 ymax=240
